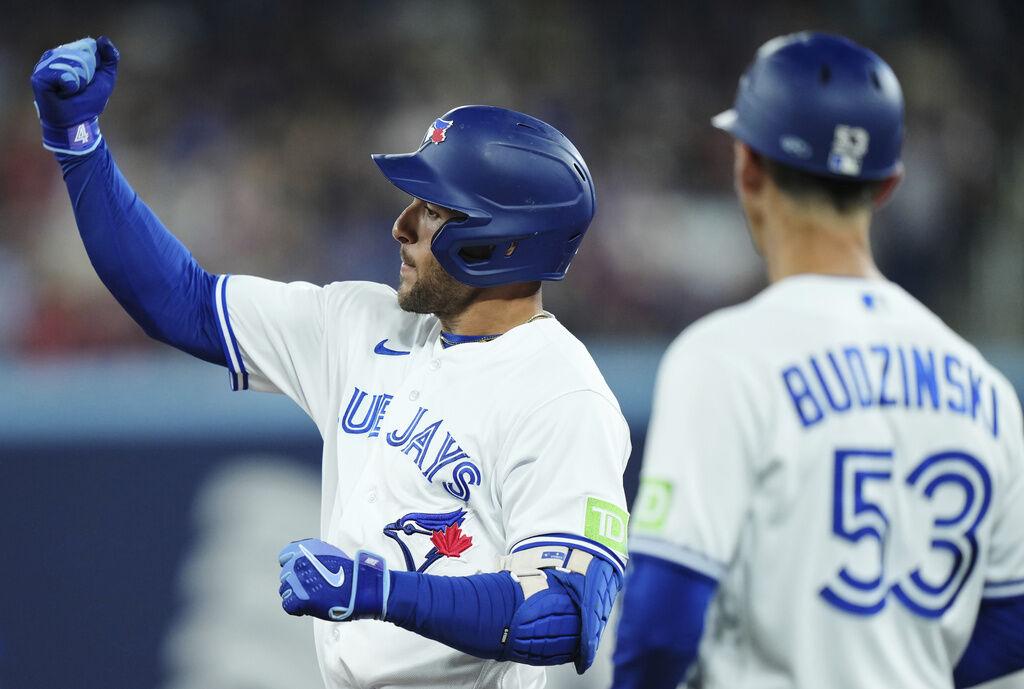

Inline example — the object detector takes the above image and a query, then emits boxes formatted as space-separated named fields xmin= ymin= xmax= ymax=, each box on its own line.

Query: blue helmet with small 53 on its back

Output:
xmin=712 ymin=32 xmax=903 ymax=180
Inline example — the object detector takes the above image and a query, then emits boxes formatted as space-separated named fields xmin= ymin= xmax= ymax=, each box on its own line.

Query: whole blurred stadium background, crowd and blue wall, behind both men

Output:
xmin=0 ymin=0 xmax=1024 ymax=689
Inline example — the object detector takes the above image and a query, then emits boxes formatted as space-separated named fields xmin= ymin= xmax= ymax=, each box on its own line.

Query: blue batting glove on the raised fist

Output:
xmin=32 ymin=36 xmax=121 ymax=156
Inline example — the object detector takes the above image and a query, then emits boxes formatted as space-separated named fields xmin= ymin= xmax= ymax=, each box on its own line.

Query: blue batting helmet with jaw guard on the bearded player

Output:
xmin=373 ymin=105 xmax=596 ymax=287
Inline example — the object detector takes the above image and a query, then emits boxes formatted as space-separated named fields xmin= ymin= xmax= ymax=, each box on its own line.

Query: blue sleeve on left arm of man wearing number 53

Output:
xmin=611 ymin=553 xmax=718 ymax=689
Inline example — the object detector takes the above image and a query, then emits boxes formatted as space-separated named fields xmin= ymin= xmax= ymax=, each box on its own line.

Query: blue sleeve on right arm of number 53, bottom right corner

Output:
xmin=953 ymin=596 xmax=1024 ymax=689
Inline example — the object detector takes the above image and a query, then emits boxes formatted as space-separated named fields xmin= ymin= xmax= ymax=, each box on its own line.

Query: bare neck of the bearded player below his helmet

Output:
xmin=438 ymin=283 xmax=544 ymax=335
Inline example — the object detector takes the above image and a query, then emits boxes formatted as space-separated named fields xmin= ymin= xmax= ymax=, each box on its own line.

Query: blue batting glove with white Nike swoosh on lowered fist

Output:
xmin=278 ymin=539 xmax=391 ymax=622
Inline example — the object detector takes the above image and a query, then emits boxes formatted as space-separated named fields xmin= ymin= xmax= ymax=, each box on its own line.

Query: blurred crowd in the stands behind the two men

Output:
xmin=0 ymin=0 xmax=1024 ymax=356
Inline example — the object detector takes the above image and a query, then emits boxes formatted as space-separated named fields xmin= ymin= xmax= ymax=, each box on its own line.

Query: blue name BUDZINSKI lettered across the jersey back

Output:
xmin=780 ymin=344 xmax=999 ymax=437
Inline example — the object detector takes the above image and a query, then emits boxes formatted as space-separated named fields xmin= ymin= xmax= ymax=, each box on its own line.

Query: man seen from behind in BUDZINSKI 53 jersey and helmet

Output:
xmin=614 ymin=33 xmax=1024 ymax=689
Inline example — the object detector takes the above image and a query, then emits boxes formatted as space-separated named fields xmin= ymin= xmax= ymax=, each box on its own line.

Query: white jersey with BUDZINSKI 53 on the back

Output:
xmin=631 ymin=275 xmax=1024 ymax=689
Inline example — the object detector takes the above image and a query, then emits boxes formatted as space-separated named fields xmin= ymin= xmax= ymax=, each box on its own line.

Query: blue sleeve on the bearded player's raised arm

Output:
xmin=57 ymin=140 xmax=227 ymax=365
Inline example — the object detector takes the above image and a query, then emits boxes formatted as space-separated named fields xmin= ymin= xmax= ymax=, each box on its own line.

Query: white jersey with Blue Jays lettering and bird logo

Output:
xmin=211 ymin=276 xmax=630 ymax=689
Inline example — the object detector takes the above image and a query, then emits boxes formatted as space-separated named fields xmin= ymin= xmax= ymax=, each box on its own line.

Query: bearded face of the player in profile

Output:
xmin=391 ymin=199 xmax=479 ymax=318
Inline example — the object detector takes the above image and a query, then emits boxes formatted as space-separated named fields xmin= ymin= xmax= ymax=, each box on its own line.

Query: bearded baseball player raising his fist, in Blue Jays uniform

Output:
xmin=32 ymin=38 xmax=630 ymax=688
